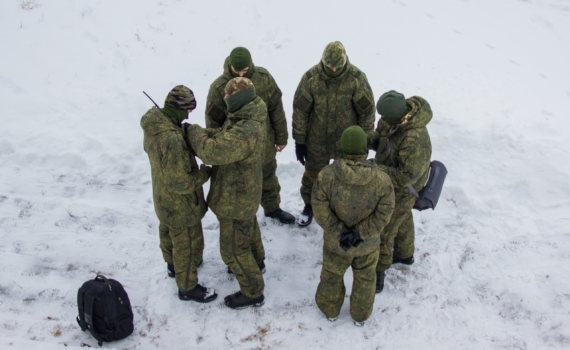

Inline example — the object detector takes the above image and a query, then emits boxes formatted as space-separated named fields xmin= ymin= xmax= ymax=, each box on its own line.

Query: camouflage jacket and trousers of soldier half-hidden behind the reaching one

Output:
xmin=206 ymin=57 xmax=289 ymax=212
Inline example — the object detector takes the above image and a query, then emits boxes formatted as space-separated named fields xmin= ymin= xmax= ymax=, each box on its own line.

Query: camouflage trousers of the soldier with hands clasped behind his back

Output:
xmin=315 ymin=251 xmax=378 ymax=322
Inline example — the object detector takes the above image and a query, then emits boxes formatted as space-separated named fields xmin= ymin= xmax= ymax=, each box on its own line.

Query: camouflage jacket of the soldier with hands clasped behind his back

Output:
xmin=311 ymin=158 xmax=394 ymax=257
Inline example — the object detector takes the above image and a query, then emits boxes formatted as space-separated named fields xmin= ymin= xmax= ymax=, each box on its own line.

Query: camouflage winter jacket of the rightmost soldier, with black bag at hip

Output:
xmin=368 ymin=96 xmax=433 ymax=193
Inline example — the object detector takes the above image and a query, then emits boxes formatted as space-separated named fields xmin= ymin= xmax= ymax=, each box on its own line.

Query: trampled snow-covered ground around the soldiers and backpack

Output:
xmin=0 ymin=0 xmax=570 ymax=349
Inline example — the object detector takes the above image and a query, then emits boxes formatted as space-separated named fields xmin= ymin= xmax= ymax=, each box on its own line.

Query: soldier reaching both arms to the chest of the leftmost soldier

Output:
xmin=188 ymin=77 xmax=267 ymax=309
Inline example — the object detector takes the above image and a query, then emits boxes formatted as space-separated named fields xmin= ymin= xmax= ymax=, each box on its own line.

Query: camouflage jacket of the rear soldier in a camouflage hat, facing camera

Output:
xmin=293 ymin=62 xmax=375 ymax=160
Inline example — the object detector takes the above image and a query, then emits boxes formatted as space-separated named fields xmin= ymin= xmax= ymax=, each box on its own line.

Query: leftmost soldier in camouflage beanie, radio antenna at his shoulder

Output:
xmin=141 ymin=85 xmax=218 ymax=303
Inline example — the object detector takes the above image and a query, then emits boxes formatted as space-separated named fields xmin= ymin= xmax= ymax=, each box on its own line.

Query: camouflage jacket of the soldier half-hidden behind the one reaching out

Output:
xmin=206 ymin=57 xmax=289 ymax=151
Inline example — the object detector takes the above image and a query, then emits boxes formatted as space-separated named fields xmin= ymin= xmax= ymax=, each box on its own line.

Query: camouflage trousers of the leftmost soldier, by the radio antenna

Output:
xmin=158 ymin=222 xmax=204 ymax=291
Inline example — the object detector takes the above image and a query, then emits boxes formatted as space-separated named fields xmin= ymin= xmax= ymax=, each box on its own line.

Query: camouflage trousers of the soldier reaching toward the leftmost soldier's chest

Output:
xmin=218 ymin=216 xmax=265 ymax=298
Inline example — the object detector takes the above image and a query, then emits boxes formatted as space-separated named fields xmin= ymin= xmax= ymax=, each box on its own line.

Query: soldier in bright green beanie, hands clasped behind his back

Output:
xmin=312 ymin=125 xmax=394 ymax=326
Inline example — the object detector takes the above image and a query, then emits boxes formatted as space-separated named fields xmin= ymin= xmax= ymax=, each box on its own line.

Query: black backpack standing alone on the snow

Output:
xmin=77 ymin=275 xmax=134 ymax=346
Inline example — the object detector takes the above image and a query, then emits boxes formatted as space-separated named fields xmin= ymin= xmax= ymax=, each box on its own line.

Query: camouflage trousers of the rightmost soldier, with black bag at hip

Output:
xmin=376 ymin=188 xmax=416 ymax=273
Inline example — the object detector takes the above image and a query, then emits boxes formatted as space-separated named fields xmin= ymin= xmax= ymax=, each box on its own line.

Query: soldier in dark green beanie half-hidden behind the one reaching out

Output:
xmin=206 ymin=47 xmax=295 ymax=224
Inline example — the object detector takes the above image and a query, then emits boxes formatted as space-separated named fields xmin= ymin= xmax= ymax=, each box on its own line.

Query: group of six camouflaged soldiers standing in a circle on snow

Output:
xmin=141 ymin=41 xmax=432 ymax=326
